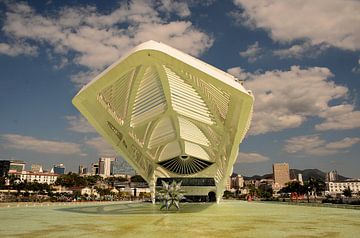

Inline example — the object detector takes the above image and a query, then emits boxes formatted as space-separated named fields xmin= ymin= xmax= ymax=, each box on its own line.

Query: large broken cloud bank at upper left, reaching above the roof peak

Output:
xmin=0 ymin=1 xmax=213 ymax=87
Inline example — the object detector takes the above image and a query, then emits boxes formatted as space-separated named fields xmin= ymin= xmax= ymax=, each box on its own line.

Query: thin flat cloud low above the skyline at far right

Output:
xmin=284 ymin=135 xmax=360 ymax=156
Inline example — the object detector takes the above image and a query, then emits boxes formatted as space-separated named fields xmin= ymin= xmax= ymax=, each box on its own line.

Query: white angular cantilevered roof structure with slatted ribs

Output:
xmin=73 ymin=41 xmax=254 ymax=203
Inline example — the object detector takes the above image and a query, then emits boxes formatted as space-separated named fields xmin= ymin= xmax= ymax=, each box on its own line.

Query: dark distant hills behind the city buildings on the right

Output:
xmin=244 ymin=169 xmax=348 ymax=181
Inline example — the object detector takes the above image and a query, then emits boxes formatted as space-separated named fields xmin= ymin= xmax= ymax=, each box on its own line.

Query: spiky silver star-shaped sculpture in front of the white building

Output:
xmin=159 ymin=180 xmax=184 ymax=210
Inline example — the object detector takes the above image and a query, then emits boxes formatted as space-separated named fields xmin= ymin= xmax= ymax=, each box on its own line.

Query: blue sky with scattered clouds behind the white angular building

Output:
xmin=0 ymin=0 xmax=360 ymax=177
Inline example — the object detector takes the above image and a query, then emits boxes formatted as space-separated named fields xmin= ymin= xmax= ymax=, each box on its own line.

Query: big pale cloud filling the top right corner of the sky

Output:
xmin=232 ymin=0 xmax=360 ymax=50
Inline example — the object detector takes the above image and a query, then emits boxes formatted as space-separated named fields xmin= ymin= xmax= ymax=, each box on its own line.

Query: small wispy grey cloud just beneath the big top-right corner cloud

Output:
xmin=273 ymin=42 xmax=328 ymax=58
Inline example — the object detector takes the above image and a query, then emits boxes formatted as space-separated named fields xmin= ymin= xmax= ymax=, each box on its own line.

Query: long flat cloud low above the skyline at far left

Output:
xmin=1 ymin=134 xmax=81 ymax=155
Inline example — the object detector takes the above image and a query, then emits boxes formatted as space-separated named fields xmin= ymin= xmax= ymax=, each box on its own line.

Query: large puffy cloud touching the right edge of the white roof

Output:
xmin=228 ymin=66 xmax=360 ymax=135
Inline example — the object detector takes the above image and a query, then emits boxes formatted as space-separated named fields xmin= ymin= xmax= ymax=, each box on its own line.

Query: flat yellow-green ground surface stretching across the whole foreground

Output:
xmin=0 ymin=201 xmax=360 ymax=238
